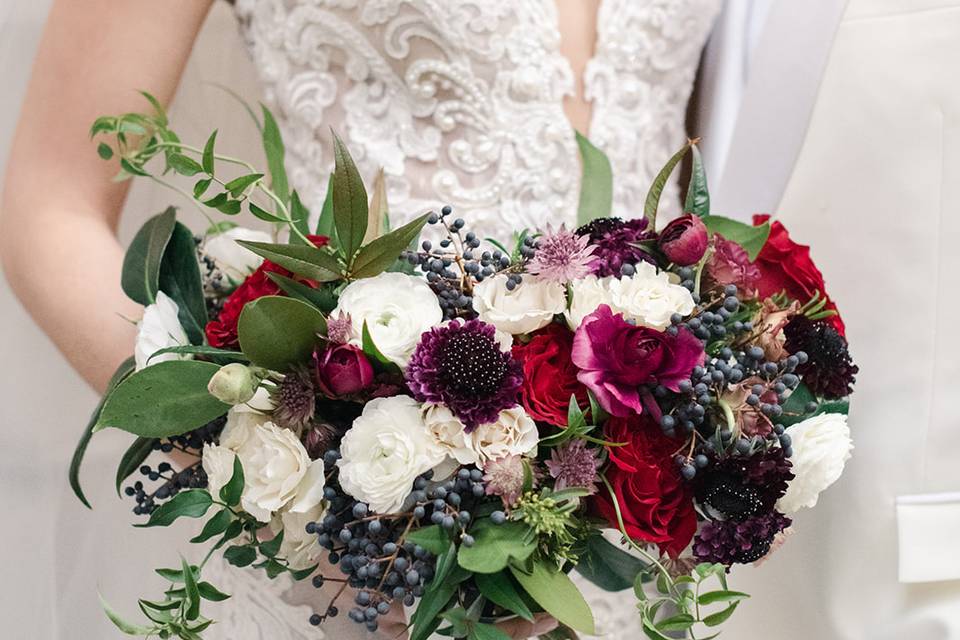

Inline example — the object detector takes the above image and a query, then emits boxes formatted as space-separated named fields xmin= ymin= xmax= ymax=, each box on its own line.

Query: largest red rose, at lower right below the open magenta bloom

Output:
xmin=593 ymin=416 xmax=697 ymax=558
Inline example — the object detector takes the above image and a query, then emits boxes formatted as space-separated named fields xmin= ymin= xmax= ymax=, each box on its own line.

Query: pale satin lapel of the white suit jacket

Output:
xmin=711 ymin=0 xmax=847 ymax=217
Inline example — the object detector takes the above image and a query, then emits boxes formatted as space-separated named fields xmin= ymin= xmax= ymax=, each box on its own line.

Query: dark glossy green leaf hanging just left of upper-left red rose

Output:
xmin=159 ymin=222 xmax=207 ymax=345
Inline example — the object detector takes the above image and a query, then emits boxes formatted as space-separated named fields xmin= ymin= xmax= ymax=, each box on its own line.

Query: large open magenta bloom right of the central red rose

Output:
xmin=571 ymin=304 xmax=705 ymax=418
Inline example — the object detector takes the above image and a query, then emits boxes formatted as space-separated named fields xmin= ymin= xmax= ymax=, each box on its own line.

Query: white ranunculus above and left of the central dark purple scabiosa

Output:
xmin=331 ymin=273 xmax=443 ymax=367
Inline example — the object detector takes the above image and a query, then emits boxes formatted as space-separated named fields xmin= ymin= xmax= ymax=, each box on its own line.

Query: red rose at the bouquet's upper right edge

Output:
xmin=753 ymin=215 xmax=845 ymax=335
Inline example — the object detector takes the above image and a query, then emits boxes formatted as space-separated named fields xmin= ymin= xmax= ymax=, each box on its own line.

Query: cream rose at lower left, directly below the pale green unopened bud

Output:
xmin=233 ymin=414 xmax=323 ymax=522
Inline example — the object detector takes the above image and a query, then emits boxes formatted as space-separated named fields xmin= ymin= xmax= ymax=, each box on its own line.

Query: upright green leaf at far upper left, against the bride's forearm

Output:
xmin=120 ymin=207 xmax=177 ymax=306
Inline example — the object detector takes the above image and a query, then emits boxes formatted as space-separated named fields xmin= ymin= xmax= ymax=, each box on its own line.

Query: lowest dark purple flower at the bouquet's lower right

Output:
xmin=693 ymin=511 xmax=791 ymax=566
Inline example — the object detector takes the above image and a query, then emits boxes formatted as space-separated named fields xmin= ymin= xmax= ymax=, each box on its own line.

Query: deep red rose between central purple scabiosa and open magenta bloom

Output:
xmin=513 ymin=324 xmax=589 ymax=427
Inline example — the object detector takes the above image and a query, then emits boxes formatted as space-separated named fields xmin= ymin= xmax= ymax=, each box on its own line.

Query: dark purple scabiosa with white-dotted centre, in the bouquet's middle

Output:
xmin=406 ymin=320 xmax=523 ymax=432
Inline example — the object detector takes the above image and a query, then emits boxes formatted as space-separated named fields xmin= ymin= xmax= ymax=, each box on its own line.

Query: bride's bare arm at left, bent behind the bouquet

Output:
xmin=0 ymin=0 xmax=210 ymax=391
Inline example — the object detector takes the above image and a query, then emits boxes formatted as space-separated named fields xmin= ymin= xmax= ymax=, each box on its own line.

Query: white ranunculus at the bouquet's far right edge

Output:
xmin=777 ymin=413 xmax=853 ymax=513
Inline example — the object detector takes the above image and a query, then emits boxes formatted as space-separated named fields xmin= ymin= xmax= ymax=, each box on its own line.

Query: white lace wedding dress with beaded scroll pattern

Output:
xmin=210 ymin=0 xmax=720 ymax=640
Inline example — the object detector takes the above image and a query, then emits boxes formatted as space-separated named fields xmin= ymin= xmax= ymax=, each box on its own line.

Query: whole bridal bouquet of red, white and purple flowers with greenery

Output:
xmin=71 ymin=96 xmax=857 ymax=640
